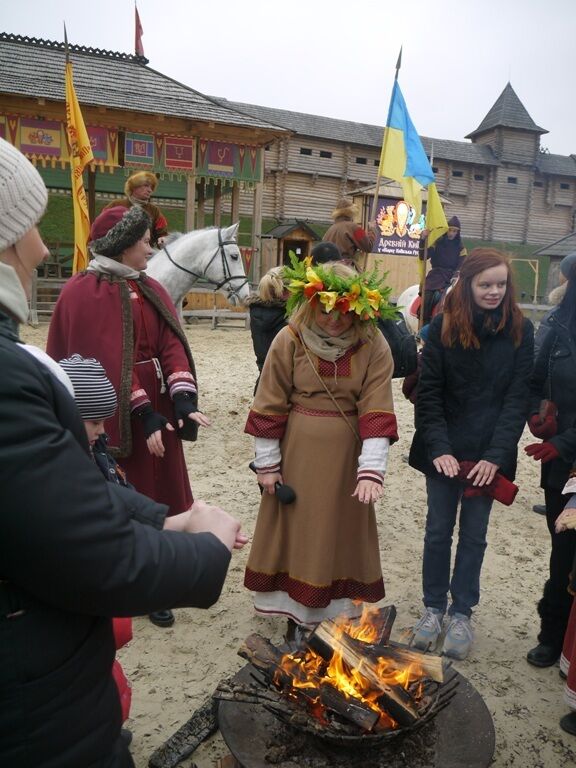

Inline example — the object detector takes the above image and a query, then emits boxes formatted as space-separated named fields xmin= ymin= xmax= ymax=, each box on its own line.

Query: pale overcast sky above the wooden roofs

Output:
xmin=0 ymin=0 xmax=576 ymax=155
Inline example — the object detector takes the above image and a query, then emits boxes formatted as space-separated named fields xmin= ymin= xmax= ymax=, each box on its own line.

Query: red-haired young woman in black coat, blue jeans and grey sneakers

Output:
xmin=410 ymin=248 xmax=534 ymax=659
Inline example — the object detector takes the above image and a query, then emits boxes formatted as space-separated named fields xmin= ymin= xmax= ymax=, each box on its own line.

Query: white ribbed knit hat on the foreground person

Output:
xmin=0 ymin=134 xmax=48 ymax=253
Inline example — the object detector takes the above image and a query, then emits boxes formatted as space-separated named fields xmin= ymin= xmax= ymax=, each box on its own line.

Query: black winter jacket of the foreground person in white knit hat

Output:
xmin=0 ymin=313 xmax=230 ymax=768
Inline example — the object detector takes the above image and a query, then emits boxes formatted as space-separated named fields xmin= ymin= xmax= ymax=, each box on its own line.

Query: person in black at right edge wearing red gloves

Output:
xmin=525 ymin=257 xmax=576 ymax=667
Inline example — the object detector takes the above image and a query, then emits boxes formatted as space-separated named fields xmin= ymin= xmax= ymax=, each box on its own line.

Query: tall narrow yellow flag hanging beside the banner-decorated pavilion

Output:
xmin=66 ymin=62 xmax=94 ymax=274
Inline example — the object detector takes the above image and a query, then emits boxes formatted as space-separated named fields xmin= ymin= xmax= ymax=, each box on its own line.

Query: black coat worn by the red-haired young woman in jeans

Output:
xmin=410 ymin=315 xmax=534 ymax=480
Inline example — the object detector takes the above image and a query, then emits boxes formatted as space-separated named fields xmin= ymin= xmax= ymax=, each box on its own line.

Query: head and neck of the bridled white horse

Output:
xmin=146 ymin=224 xmax=250 ymax=307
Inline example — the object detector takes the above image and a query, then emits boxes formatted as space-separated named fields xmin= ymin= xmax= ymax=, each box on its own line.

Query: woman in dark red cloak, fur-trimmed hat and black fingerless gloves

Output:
xmin=47 ymin=206 xmax=209 ymax=626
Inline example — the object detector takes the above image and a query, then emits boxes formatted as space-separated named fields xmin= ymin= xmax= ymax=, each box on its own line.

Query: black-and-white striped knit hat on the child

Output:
xmin=59 ymin=355 xmax=118 ymax=421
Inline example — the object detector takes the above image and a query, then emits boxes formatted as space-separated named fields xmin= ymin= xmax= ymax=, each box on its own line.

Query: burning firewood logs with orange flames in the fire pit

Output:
xmin=228 ymin=606 xmax=451 ymax=738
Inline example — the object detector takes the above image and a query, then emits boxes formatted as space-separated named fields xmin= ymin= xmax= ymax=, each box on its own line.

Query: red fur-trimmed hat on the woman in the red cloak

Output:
xmin=90 ymin=205 xmax=152 ymax=259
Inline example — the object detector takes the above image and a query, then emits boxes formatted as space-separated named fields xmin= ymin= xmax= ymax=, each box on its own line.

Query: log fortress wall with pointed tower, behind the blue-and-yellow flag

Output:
xmin=221 ymin=83 xmax=576 ymax=245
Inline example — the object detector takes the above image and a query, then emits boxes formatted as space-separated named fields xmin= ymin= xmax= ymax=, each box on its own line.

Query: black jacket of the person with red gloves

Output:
xmin=530 ymin=308 xmax=576 ymax=490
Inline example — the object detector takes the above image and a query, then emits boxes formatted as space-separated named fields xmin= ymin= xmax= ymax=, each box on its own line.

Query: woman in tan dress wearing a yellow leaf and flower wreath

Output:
xmin=244 ymin=258 xmax=398 ymax=634
